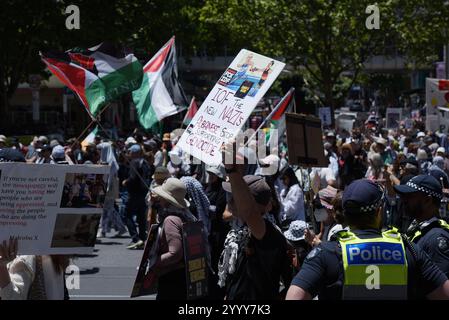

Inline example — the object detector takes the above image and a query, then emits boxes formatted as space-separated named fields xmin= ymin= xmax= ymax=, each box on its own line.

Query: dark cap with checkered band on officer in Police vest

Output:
xmin=342 ymin=179 xmax=384 ymax=213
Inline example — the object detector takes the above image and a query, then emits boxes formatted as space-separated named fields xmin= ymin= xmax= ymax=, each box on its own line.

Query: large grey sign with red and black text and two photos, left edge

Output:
xmin=0 ymin=163 xmax=110 ymax=255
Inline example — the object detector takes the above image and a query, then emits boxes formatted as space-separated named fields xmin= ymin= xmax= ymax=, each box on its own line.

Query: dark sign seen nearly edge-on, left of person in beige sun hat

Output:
xmin=131 ymin=224 xmax=162 ymax=298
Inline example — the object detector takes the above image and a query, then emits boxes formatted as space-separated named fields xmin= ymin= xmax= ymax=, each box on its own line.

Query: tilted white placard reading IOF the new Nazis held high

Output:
xmin=177 ymin=49 xmax=285 ymax=165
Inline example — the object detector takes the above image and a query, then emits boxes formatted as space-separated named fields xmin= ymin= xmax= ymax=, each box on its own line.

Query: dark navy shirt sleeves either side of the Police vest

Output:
xmin=292 ymin=230 xmax=447 ymax=300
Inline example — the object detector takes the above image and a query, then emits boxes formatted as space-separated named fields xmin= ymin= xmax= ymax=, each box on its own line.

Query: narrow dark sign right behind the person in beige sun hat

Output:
xmin=183 ymin=221 xmax=208 ymax=300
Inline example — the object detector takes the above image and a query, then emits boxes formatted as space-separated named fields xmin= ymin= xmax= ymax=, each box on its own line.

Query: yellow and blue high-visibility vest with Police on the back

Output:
xmin=338 ymin=229 xmax=408 ymax=300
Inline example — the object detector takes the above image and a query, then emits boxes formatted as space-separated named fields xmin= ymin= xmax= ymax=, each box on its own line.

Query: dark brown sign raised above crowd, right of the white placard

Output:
xmin=285 ymin=113 xmax=329 ymax=167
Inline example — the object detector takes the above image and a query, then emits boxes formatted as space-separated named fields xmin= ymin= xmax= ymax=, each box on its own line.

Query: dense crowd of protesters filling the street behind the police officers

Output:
xmin=0 ymin=112 xmax=449 ymax=300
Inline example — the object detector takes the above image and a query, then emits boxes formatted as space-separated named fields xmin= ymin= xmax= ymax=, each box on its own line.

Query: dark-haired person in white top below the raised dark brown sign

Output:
xmin=279 ymin=167 xmax=306 ymax=228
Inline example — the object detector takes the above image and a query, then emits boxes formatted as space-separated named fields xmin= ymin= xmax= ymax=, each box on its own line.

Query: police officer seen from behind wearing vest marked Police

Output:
xmin=287 ymin=179 xmax=449 ymax=300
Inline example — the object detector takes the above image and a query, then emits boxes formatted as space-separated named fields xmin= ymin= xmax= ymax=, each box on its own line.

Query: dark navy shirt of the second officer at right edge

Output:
xmin=416 ymin=222 xmax=449 ymax=277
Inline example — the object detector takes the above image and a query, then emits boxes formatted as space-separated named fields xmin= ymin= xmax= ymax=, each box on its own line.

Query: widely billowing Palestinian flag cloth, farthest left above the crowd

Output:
xmin=41 ymin=42 xmax=143 ymax=116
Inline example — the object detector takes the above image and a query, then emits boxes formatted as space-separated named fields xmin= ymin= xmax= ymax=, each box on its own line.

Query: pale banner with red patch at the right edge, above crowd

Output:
xmin=426 ymin=78 xmax=449 ymax=133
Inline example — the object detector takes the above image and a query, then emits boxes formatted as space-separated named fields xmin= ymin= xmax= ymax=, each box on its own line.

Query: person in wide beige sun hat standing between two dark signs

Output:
xmin=152 ymin=178 xmax=196 ymax=300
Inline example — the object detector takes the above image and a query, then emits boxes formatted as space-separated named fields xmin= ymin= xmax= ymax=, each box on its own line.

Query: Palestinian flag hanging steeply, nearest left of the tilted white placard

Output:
xmin=133 ymin=37 xmax=189 ymax=129
